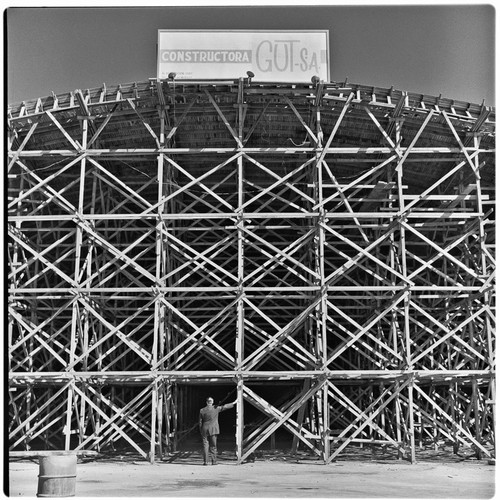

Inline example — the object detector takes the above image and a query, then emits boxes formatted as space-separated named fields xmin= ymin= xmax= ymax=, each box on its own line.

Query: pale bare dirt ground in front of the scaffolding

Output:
xmin=8 ymin=452 xmax=495 ymax=499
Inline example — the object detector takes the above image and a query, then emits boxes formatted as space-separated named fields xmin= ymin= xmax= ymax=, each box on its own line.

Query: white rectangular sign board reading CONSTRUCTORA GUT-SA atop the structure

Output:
xmin=157 ymin=30 xmax=330 ymax=82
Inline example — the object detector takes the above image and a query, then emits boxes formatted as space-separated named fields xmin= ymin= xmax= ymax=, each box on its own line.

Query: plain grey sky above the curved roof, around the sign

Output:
xmin=4 ymin=0 xmax=495 ymax=106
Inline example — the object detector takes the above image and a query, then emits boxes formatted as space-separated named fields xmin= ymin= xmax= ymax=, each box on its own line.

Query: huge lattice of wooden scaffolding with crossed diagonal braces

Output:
xmin=7 ymin=78 xmax=495 ymax=463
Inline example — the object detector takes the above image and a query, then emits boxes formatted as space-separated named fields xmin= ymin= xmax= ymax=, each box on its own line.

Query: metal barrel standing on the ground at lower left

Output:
xmin=36 ymin=453 xmax=76 ymax=497
